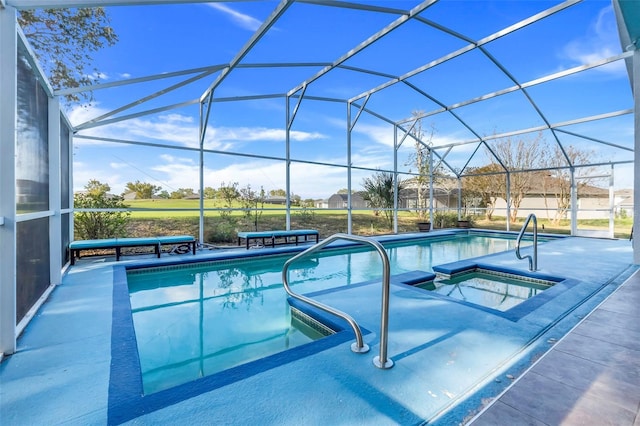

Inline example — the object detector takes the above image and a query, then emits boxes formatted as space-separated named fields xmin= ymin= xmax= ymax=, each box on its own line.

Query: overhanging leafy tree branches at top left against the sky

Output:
xmin=18 ymin=7 xmax=118 ymax=102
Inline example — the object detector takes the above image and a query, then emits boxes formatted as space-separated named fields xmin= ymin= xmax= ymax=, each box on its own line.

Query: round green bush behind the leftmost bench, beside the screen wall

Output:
xmin=73 ymin=180 xmax=130 ymax=240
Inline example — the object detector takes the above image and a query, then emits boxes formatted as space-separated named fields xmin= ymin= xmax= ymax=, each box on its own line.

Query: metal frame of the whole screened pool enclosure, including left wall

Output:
xmin=0 ymin=0 xmax=640 ymax=353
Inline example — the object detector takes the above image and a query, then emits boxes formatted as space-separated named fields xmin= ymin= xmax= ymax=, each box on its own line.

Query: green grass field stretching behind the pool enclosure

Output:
xmin=116 ymin=200 xmax=632 ymax=244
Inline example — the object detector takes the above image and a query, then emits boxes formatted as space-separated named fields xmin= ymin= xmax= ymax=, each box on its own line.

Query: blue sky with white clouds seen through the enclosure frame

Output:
xmin=62 ymin=0 xmax=633 ymax=198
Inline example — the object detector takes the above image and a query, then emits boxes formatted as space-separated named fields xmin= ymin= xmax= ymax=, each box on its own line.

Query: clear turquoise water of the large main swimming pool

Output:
xmin=127 ymin=235 xmax=536 ymax=394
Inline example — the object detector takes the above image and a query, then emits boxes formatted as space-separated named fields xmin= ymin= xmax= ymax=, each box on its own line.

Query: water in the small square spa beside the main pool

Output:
xmin=416 ymin=271 xmax=555 ymax=312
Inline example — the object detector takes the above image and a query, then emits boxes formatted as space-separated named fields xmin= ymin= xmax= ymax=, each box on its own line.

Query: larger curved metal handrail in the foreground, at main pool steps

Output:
xmin=282 ymin=234 xmax=393 ymax=369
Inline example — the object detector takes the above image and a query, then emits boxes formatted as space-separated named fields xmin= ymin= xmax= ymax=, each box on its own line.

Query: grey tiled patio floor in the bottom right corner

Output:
xmin=473 ymin=273 xmax=640 ymax=426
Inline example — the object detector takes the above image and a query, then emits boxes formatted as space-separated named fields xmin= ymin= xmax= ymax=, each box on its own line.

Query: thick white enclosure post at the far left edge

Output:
xmin=0 ymin=6 xmax=18 ymax=355
